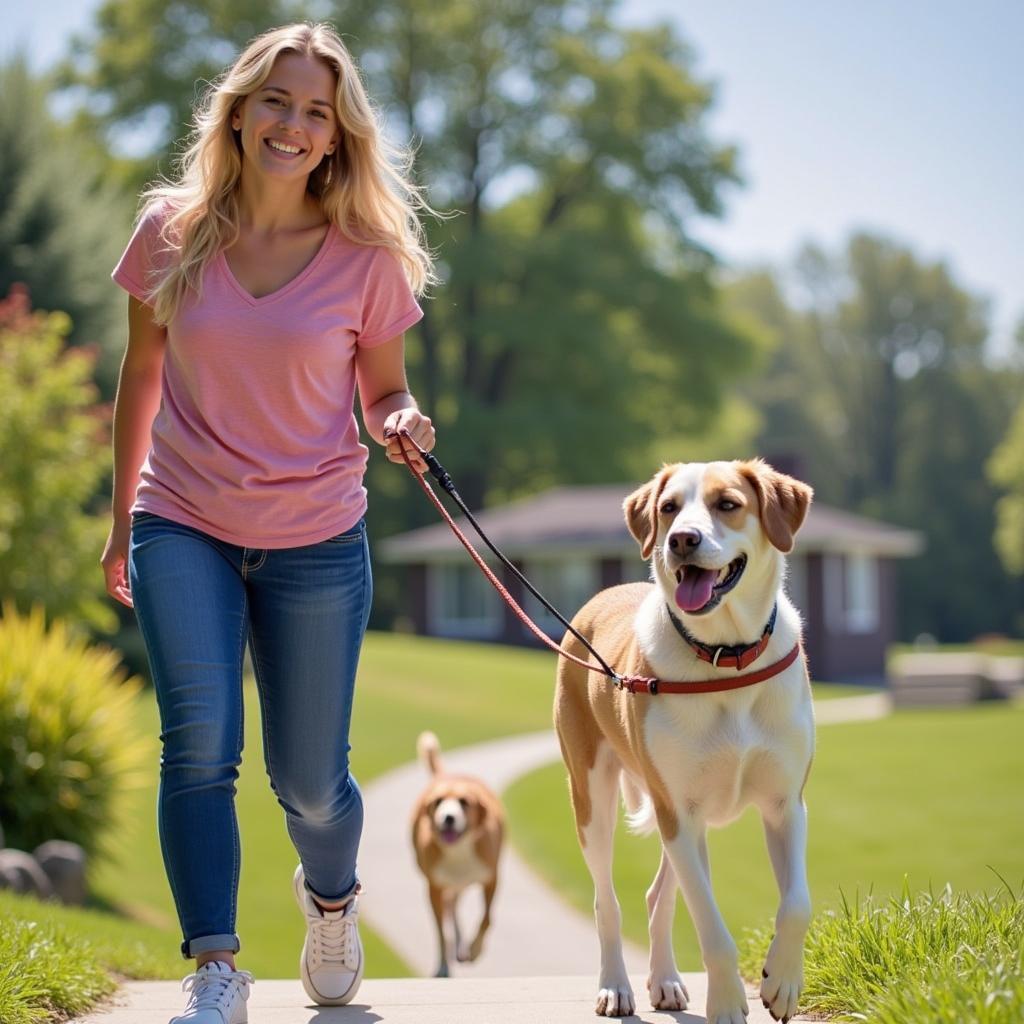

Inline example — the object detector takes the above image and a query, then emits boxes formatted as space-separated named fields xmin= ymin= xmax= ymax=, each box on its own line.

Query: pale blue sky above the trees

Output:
xmin=4 ymin=0 xmax=1024 ymax=348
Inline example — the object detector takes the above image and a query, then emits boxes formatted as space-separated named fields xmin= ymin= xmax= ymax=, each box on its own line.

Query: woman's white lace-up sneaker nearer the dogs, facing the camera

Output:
xmin=293 ymin=864 xmax=362 ymax=1007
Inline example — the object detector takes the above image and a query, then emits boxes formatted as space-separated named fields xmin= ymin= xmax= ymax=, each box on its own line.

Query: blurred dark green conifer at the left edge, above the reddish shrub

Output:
xmin=0 ymin=55 xmax=132 ymax=395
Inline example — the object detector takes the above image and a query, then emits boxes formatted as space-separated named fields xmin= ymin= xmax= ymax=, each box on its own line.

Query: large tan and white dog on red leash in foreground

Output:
xmin=555 ymin=460 xmax=814 ymax=1024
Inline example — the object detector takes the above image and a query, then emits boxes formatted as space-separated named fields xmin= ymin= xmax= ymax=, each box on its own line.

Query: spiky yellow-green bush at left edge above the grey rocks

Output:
xmin=0 ymin=603 xmax=147 ymax=854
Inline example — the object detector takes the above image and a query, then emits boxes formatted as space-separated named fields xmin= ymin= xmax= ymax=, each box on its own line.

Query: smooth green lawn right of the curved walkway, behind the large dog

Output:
xmin=506 ymin=705 xmax=1024 ymax=970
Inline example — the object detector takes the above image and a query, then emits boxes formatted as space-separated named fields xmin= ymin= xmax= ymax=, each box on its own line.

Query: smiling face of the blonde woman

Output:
xmin=231 ymin=53 xmax=340 ymax=185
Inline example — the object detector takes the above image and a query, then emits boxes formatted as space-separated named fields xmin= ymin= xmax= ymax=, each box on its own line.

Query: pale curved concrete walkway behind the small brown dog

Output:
xmin=359 ymin=694 xmax=890 ymax=978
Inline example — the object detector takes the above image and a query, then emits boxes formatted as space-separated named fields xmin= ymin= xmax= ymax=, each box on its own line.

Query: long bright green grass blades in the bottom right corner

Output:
xmin=740 ymin=880 xmax=1024 ymax=1024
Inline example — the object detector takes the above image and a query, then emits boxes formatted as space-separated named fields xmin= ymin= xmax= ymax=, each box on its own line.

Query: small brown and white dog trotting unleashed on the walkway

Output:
xmin=413 ymin=732 xmax=505 ymax=978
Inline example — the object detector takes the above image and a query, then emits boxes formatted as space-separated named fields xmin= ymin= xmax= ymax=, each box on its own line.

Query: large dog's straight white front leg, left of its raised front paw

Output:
xmin=665 ymin=821 xmax=748 ymax=1024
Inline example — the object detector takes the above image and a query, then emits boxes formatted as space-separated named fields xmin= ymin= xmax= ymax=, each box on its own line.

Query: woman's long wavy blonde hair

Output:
xmin=142 ymin=23 xmax=437 ymax=324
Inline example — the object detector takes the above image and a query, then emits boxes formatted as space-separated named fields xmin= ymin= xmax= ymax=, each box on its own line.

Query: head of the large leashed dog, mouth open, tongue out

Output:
xmin=623 ymin=459 xmax=812 ymax=615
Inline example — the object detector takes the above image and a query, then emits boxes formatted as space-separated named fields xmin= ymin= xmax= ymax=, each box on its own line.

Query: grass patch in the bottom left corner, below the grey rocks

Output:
xmin=0 ymin=892 xmax=181 ymax=1024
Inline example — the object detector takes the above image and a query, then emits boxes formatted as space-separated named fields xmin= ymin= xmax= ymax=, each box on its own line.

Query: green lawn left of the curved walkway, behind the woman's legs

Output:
xmin=93 ymin=634 xmax=554 ymax=978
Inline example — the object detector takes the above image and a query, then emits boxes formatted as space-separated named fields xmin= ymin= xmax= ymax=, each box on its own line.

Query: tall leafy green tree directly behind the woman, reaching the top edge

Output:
xmin=58 ymin=0 xmax=754 ymax=516
